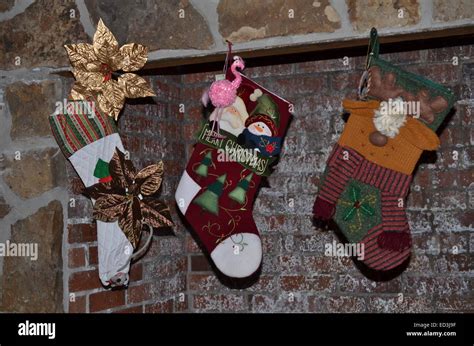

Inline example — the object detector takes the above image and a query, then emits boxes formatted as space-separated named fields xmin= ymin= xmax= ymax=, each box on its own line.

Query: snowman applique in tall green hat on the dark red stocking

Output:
xmin=237 ymin=94 xmax=282 ymax=157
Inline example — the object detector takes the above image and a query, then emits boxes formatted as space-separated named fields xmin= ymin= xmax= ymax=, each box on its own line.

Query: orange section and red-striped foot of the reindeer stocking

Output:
xmin=313 ymin=100 xmax=439 ymax=270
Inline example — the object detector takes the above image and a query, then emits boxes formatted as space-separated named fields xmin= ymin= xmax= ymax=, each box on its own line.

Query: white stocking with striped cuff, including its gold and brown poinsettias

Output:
xmin=50 ymin=20 xmax=172 ymax=286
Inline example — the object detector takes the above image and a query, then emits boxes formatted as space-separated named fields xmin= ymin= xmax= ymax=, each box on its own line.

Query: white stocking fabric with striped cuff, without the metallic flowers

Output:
xmin=50 ymin=101 xmax=133 ymax=286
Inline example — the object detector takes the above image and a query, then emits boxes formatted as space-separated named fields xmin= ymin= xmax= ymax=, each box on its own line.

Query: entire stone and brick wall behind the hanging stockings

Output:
xmin=0 ymin=0 xmax=474 ymax=312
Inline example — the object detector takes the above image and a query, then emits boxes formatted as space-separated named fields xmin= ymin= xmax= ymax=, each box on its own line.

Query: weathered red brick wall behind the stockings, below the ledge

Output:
xmin=66 ymin=45 xmax=474 ymax=312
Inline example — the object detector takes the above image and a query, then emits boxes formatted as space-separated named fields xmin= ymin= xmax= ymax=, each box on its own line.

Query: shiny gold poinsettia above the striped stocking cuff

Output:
xmin=64 ymin=19 xmax=155 ymax=120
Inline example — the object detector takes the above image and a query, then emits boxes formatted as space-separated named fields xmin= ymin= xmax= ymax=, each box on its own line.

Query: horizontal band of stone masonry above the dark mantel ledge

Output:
xmin=0 ymin=0 xmax=474 ymax=70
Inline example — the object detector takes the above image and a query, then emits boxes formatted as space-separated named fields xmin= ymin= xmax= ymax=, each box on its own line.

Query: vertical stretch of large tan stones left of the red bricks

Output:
xmin=0 ymin=71 xmax=68 ymax=312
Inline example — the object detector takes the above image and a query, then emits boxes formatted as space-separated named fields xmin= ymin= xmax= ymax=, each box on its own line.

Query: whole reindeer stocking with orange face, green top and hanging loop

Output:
xmin=313 ymin=29 xmax=454 ymax=270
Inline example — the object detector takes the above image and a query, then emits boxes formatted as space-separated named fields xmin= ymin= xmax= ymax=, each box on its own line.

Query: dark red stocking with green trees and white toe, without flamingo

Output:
xmin=175 ymin=71 xmax=290 ymax=278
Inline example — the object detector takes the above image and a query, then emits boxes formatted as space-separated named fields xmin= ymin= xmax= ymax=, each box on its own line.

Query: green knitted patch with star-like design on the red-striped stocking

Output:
xmin=334 ymin=179 xmax=382 ymax=243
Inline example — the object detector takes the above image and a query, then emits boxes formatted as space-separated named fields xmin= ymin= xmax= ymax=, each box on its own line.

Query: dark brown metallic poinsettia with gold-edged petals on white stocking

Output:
xmin=86 ymin=149 xmax=173 ymax=248
